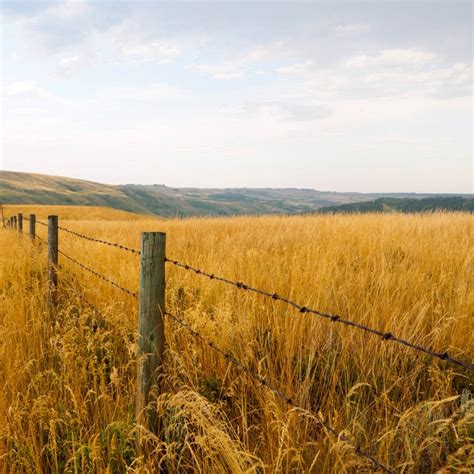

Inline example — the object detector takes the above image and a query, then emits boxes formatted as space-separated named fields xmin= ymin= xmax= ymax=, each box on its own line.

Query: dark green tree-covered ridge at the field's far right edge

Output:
xmin=318 ymin=196 xmax=474 ymax=214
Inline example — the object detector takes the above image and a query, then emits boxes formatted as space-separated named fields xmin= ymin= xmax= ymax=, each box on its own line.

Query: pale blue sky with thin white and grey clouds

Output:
xmin=0 ymin=0 xmax=473 ymax=193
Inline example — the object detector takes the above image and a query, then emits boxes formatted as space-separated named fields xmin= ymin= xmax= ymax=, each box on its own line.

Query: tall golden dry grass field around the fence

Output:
xmin=0 ymin=207 xmax=474 ymax=473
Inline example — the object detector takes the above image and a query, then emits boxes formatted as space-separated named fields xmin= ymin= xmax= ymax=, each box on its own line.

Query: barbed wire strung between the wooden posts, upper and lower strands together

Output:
xmin=2 ymin=210 xmax=474 ymax=473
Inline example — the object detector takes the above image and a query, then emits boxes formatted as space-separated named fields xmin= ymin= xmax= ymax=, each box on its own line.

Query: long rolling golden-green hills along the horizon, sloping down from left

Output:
xmin=0 ymin=171 xmax=468 ymax=217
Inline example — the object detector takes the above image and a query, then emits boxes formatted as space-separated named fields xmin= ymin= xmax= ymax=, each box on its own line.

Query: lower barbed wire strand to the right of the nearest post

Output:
xmin=165 ymin=312 xmax=393 ymax=474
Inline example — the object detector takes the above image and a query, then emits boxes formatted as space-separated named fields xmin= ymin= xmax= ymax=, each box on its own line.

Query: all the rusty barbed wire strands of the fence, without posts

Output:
xmin=6 ymin=215 xmax=474 ymax=473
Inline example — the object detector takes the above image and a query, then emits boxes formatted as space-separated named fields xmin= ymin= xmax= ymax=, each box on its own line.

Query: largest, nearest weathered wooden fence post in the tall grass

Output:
xmin=135 ymin=232 xmax=166 ymax=441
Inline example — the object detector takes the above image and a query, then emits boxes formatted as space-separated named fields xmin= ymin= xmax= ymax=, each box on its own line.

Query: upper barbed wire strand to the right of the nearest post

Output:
xmin=166 ymin=258 xmax=474 ymax=371
